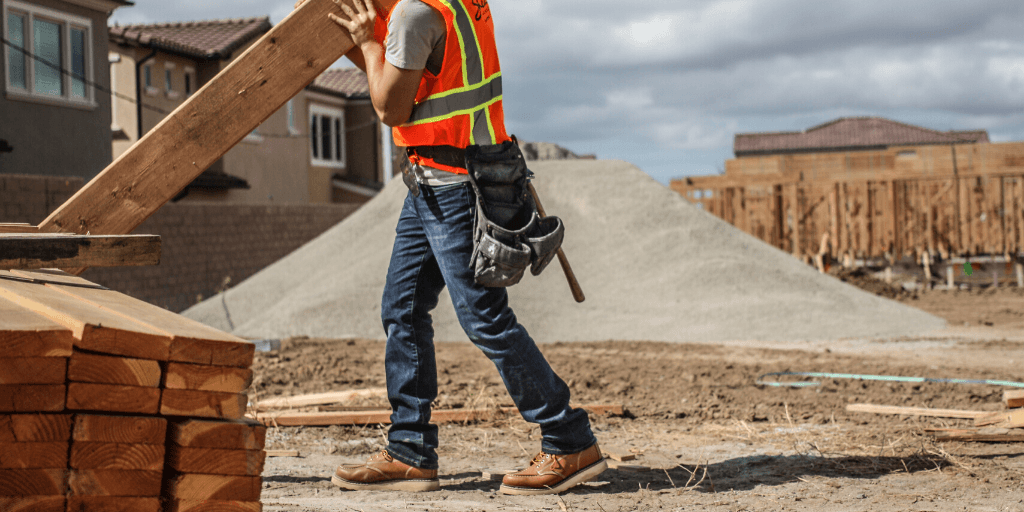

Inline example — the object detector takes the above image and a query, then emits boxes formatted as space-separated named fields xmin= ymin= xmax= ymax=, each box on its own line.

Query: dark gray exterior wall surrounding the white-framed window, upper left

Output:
xmin=0 ymin=0 xmax=111 ymax=179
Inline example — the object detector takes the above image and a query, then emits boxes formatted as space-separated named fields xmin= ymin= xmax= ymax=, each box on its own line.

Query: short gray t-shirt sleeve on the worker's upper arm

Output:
xmin=384 ymin=0 xmax=445 ymax=70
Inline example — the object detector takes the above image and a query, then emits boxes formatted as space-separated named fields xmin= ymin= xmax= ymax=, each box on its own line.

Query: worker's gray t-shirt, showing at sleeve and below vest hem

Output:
xmin=384 ymin=0 xmax=469 ymax=186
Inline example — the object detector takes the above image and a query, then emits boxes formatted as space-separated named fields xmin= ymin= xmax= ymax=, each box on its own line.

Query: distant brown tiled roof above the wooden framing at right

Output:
xmin=733 ymin=118 xmax=988 ymax=157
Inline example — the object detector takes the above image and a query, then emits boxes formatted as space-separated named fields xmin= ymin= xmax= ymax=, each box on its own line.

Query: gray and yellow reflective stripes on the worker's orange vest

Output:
xmin=399 ymin=0 xmax=504 ymax=145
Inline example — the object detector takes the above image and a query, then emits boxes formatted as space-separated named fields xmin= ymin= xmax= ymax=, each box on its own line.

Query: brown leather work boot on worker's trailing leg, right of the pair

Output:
xmin=501 ymin=443 xmax=608 ymax=495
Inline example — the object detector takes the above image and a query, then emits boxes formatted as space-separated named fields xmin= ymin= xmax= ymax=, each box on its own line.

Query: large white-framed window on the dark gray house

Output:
xmin=3 ymin=0 xmax=93 ymax=103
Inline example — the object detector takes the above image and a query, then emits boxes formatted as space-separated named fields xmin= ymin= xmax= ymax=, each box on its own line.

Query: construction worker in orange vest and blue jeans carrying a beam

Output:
xmin=297 ymin=0 xmax=606 ymax=495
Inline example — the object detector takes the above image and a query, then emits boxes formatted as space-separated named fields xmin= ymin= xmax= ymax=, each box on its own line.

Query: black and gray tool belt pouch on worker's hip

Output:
xmin=466 ymin=141 xmax=564 ymax=287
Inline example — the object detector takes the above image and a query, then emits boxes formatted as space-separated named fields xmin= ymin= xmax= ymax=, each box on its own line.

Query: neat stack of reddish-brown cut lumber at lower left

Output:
xmin=0 ymin=270 xmax=265 ymax=512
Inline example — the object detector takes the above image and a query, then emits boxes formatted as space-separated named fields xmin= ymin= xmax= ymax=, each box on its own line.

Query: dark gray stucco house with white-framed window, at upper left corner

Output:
xmin=0 ymin=0 xmax=132 ymax=180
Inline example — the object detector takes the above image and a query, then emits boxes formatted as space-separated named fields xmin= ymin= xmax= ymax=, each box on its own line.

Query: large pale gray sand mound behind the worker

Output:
xmin=184 ymin=161 xmax=944 ymax=342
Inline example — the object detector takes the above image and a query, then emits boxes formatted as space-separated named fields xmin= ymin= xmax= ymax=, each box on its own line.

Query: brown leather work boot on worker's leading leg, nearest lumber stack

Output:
xmin=331 ymin=450 xmax=441 ymax=492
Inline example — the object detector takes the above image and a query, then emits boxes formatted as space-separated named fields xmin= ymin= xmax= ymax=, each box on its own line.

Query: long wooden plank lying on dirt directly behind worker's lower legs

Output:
xmin=256 ymin=404 xmax=623 ymax=427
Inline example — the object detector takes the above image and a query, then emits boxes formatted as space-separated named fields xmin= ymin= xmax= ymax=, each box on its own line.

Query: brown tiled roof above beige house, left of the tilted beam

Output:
xmin=110 ymin=16 xmax=270 ymax=59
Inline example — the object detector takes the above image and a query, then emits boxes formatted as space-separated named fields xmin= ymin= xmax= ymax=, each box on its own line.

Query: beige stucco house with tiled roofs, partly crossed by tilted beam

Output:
xmin=110 ymin=17 xmax=385 ymax=204
